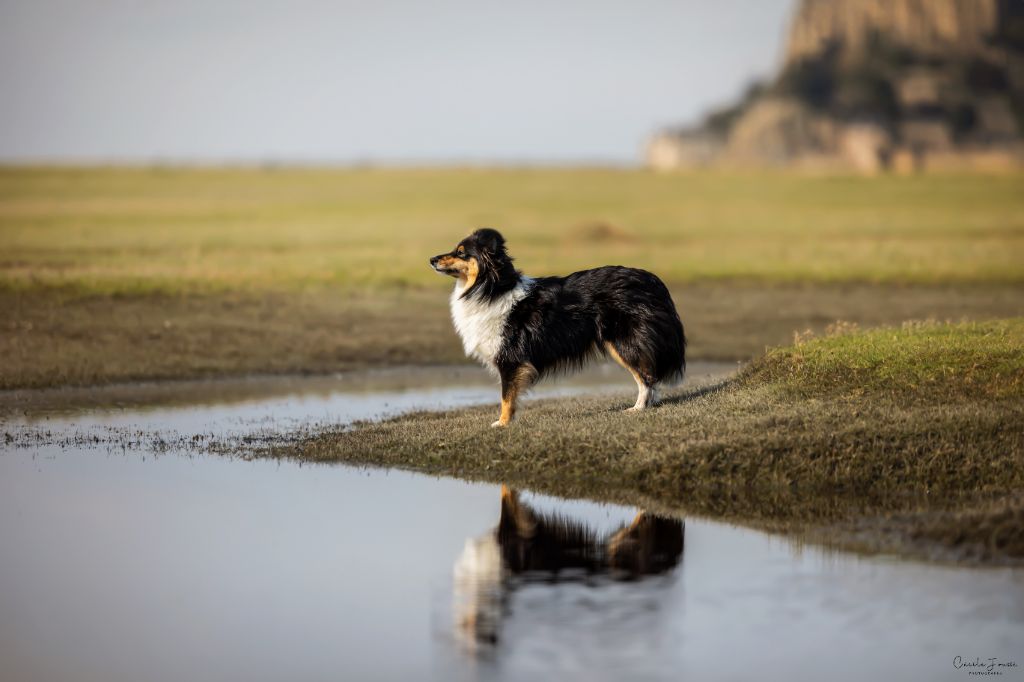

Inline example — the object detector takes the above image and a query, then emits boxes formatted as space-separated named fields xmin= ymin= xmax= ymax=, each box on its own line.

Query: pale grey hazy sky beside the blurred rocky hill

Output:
xmin=0 ymin=0 xmax=794 ymax=163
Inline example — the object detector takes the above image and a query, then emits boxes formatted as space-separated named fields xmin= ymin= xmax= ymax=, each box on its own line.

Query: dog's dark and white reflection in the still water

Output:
xmin=455 ymin=485 xmax=683 ymax=651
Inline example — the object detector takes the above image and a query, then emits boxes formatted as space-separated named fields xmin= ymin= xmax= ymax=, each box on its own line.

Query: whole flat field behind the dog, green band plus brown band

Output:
xmin=0 ymin=168 xmax=1024 ymax=388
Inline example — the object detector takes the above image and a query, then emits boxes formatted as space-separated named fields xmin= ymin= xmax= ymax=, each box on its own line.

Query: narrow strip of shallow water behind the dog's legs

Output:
xmin=0 ymin=361 xmax=737 ymax=441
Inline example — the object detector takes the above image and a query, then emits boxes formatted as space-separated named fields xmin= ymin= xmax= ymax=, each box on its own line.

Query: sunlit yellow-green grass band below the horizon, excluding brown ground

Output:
xmin=0 ymin=168 xmax=1024 ymax=293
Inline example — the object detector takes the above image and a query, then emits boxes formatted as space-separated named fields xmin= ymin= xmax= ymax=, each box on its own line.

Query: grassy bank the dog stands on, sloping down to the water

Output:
xmin=275 ymin=318 xmax=1024 ymax=560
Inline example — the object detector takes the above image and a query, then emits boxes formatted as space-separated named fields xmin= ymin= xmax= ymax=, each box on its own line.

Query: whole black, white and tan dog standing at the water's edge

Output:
xmin=430 ymin=229 xmax=686 ymax=426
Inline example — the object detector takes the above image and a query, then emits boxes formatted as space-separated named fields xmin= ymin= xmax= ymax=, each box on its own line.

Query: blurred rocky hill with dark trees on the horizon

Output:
xmin=646 ymin=0 xmax=1024 ymax=173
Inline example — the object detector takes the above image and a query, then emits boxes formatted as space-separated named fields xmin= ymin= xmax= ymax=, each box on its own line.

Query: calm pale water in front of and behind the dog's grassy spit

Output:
xmin=0 ymin=364 xmax=1024 ymax=681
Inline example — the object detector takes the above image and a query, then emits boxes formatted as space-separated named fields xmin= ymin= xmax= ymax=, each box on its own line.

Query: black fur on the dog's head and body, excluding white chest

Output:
xmin=431 ymin=229 xmax=686 ymax=386
